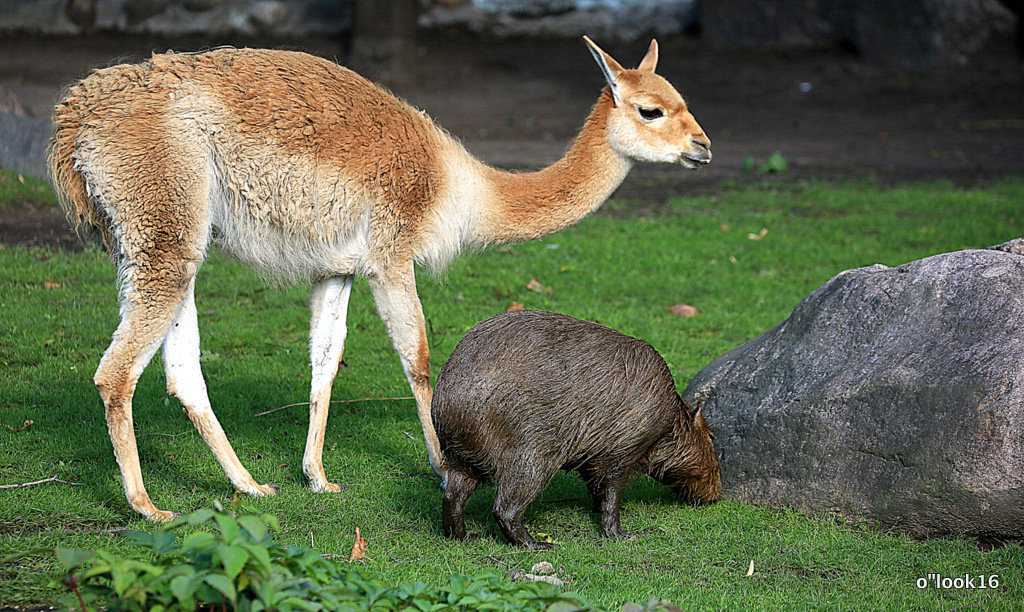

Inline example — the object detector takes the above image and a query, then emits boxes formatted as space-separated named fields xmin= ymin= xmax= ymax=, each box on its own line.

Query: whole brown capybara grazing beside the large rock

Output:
xmin=431 ymin=310 xmax=721 ymax=548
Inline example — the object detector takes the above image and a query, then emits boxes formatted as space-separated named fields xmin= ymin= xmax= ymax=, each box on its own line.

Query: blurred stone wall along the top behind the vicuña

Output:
xmin=0 ymin=0 xmax=1024 ymax=69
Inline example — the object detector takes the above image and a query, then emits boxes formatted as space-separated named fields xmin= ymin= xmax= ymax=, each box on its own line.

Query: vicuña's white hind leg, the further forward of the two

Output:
xmin=163 ymin=277 xmax=276 ymax=496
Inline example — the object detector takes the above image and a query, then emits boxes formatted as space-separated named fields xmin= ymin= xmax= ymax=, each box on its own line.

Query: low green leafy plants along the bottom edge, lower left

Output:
xmin=49 ymin=510 xmax=638 ymax=612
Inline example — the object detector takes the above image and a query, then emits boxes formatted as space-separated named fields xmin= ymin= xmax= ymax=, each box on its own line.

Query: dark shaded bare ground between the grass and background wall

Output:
xmin=0 ymin=0 xmax=1024 ymax=249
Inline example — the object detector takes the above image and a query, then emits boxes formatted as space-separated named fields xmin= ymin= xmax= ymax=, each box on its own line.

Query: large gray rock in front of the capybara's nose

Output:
xmin=683 ymin=251 xmax=1024 ymax=538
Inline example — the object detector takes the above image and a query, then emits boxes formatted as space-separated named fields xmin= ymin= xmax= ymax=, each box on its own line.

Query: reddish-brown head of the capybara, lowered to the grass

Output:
xmin=647 ymin=400 xmax=722 ymax=505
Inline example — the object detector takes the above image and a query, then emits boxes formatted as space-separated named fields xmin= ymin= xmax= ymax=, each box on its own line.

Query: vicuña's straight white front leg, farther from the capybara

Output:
xmin=302 ymin=276 xmax=352 ymax=493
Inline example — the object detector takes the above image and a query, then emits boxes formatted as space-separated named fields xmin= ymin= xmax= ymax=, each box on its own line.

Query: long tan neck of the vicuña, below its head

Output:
xmin=473 ymin=90 xmax=633 ymax=245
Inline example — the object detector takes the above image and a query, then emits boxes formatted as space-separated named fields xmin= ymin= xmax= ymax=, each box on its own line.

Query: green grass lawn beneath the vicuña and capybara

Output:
xmin=0 ymin=179 xmax=1024 ymax=610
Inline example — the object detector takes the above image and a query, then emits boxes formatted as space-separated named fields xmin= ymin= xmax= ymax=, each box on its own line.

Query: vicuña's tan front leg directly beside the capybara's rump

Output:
xmin=369 ymin=262 xmax=447 ymax=487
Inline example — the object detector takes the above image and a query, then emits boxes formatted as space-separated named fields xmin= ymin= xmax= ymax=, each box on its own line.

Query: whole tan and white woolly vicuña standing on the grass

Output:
xmin=49 ymin=37 xmax=711 ymax=520
